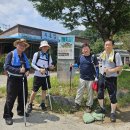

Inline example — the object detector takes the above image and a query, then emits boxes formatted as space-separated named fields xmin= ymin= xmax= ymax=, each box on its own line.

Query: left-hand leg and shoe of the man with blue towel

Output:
xmin=3 ymin=77 xmax=18 ymax=125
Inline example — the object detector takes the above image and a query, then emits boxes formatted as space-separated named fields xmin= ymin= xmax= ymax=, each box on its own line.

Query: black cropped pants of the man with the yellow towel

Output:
xmin=98 ymin=75 xmax=117 ymax=104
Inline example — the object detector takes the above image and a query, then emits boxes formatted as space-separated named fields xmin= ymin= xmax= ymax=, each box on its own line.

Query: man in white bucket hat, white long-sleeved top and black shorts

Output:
xmin=27 ymin=41 xmax=54 ymax=113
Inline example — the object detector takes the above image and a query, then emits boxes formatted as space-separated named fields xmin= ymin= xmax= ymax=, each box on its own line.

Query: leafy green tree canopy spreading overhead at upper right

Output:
xmin=29 ymin=0 xmax=130 ymax=40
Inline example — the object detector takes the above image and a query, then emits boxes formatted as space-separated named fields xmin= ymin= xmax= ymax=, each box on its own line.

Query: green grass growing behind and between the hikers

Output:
xmin=0 ymin=71 xmax=130 ymax=113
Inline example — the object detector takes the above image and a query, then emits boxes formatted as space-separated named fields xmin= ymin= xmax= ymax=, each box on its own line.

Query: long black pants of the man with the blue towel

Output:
xmin=3 ymin=76 xmax=28 ymax=118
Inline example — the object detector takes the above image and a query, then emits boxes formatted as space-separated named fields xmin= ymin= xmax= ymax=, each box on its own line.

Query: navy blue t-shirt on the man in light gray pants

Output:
xmin=77 ymin=55 xmax=98 ymax=81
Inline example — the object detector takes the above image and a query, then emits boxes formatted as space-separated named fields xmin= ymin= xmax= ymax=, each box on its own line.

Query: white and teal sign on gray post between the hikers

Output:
xmin=57 ymin=35 xmax=75 ymax=82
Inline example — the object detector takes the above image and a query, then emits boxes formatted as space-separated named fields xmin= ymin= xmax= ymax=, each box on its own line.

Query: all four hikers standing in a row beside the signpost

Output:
xmin=3 ymin=39 xmax=122 ymax=125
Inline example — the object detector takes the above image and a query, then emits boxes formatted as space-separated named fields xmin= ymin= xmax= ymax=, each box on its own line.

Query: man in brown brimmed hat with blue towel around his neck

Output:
xmin=3 ymin=39 xmax=30 ymax=125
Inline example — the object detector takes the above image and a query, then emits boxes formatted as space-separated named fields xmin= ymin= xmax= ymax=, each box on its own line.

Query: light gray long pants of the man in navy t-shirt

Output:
xmin=75 ymin=78 xmax=93 ymax=106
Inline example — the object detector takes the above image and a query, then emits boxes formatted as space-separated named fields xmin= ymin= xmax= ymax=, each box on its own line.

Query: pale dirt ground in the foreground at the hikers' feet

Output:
xmin=0 ymin=98 xmax=130 ymax=130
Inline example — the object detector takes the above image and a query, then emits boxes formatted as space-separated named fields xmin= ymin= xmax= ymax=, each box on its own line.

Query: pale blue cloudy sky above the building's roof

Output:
xmin=0 ymin=0 xmax=84 ymax=33
